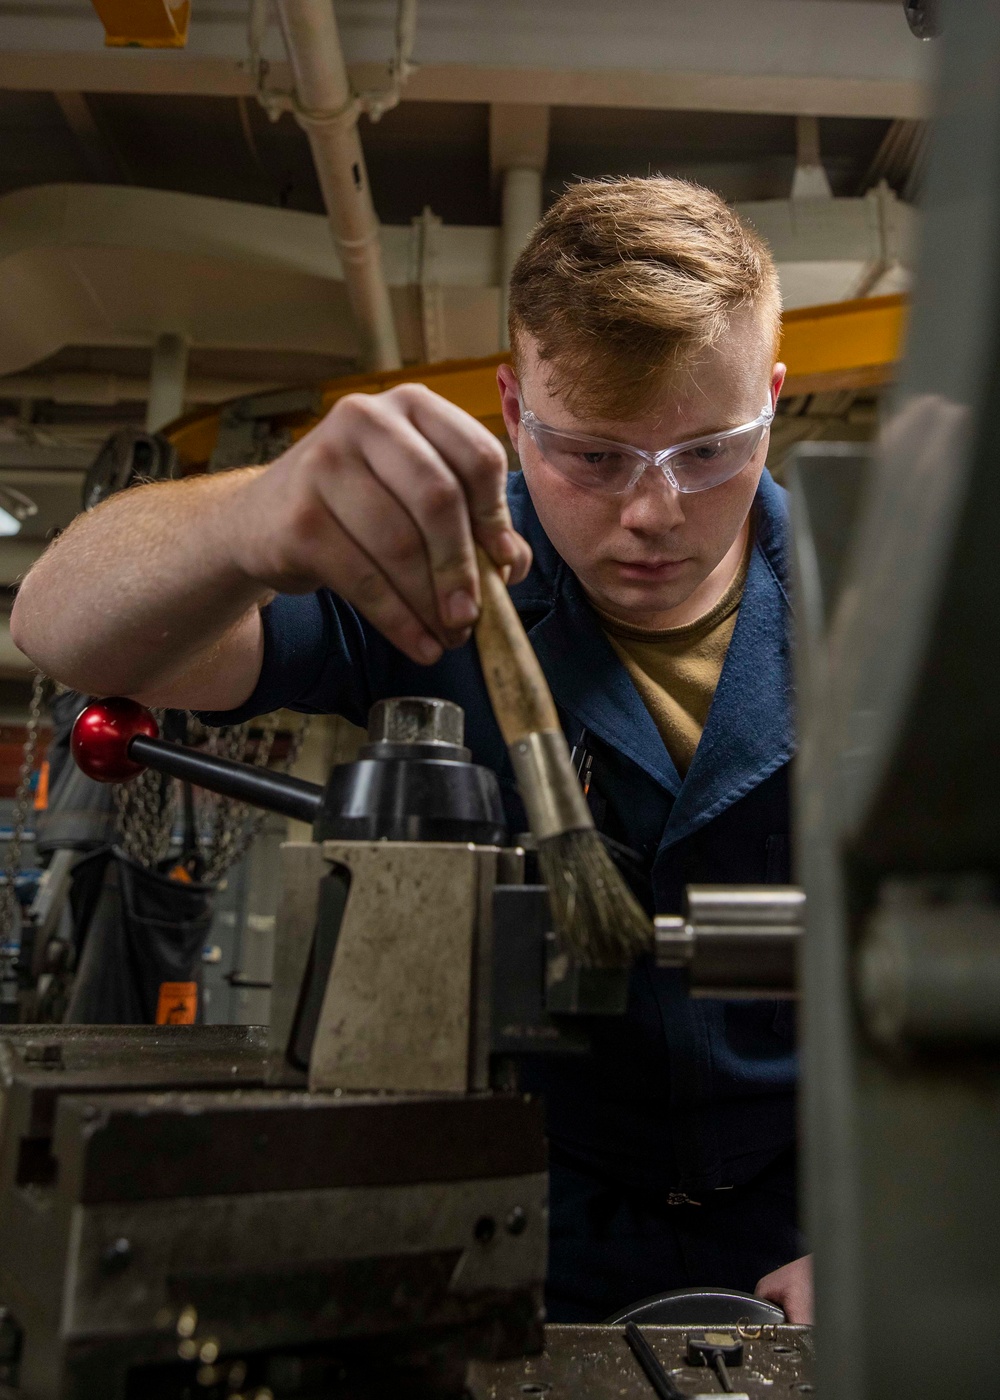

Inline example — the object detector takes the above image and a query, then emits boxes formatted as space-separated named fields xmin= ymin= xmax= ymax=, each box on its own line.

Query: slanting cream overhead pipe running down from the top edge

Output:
xmin=277 ymin=0 xmax=402 ymax=370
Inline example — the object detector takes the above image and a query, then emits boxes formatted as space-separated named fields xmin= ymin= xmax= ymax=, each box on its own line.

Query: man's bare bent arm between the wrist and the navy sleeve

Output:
xmin=11 ymin=468 xmax=268 ymax=694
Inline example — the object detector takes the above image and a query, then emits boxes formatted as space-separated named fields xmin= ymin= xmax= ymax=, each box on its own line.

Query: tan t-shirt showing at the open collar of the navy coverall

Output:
xmin=595 ymin=536 xmax=754 ymax=777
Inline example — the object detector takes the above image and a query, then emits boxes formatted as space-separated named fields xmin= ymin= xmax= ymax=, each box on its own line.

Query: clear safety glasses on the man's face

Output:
xmin=518 ymin=396 xmax=775 ymax=496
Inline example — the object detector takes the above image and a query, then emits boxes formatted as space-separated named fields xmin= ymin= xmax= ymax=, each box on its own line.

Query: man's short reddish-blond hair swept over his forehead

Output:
xmin=508 ymin=175 xmax=782 ymax=420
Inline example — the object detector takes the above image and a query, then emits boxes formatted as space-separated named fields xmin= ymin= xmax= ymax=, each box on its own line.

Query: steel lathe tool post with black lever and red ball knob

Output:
xmin=73 ymin=697 xmax=655 ymax=1092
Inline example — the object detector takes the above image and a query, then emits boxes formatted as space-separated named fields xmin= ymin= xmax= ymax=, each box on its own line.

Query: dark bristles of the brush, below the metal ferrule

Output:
xmin=538 ymin=829 xmax=653 ymax=967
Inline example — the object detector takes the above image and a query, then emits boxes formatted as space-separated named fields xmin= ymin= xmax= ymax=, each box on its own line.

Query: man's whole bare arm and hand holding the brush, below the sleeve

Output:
xmin=11 ymin=384 xmax=531 ymax=710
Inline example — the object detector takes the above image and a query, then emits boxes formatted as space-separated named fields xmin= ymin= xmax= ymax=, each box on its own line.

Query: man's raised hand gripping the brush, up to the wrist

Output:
xmin=232 ymin=384 xmax=531 ymax=664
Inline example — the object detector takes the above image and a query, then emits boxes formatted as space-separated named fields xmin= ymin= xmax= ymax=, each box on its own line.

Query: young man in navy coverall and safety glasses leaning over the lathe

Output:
xmin=13 ymin=178 xmax=810 ymax=1322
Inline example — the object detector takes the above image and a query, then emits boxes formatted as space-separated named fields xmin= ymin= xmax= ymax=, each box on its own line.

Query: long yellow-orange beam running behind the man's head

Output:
xmin=168 ymin=297 xmax=906 ymax=472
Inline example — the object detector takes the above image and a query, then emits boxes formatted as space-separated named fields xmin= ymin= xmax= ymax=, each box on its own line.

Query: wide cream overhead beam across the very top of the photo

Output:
xmin=0 ymin=0 xmax=933 ymax=116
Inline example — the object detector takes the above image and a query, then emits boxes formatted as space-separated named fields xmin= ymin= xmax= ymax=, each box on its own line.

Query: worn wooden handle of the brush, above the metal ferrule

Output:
xmin=476 ymin=546 xmax=562 ymax=748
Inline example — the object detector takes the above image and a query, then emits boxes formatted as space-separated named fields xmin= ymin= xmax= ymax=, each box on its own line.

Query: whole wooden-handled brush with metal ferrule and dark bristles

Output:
xmin=476 ymin=549 xmax=653 ymax=967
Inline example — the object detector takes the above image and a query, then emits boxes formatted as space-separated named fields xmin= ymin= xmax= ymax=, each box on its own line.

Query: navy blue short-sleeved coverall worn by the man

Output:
xmin=203 ymin=472 xmax=804 ymax=1322
